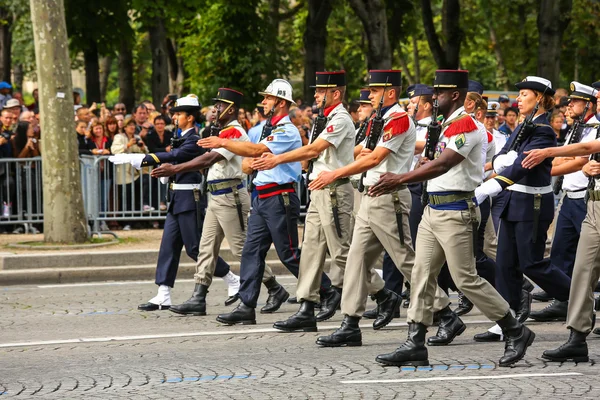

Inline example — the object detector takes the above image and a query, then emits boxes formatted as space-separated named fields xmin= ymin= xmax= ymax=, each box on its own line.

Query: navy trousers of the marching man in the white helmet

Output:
xmin=239 ymin=193 xmax=331 ymax=308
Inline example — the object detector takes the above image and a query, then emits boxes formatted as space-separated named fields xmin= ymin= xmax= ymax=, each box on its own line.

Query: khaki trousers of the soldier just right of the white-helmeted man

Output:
xmin=296 ymin=183 xmax=354 ymax=303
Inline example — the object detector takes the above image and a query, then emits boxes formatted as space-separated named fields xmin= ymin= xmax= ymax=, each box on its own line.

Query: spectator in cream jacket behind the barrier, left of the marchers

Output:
xmin=110 ymin=116 xmax=148 ymax=231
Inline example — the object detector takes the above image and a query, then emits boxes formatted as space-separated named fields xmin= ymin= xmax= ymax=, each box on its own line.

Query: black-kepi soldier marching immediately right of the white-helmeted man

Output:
xmin=252 ymin=71 xmax=355 ymax=332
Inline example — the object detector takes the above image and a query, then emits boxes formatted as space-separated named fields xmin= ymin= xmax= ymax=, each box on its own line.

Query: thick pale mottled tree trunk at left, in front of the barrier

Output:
xmin=30 ymin=0 xmax=87 ymax=243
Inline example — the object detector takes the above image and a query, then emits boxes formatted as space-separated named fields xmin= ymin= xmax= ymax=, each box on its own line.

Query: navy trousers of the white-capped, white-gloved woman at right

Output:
xmin=496 ymin=218 xmax=571 ymax=310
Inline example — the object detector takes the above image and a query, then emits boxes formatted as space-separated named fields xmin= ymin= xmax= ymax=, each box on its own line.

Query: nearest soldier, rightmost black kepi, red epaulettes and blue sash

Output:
xmin=369 ymin=70 xmax=535 ymax=366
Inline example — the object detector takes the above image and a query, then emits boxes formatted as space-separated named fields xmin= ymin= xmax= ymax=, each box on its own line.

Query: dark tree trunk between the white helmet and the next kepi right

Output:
xmin=303 ymin=0 xmax=333 ymax=104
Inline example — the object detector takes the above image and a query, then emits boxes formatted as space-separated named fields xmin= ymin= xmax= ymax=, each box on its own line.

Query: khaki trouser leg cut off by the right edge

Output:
xmin=567 ymin=200 xmax=600 ymax=333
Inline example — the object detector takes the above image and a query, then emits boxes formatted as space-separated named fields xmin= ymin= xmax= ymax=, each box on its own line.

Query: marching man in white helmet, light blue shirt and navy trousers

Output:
xmin=198 ymin=79 xmax=331 ymax=325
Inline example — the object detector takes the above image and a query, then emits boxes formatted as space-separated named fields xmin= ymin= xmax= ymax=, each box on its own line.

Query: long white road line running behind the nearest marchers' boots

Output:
xmin=0 ymin=320 xmax=490 ymax=348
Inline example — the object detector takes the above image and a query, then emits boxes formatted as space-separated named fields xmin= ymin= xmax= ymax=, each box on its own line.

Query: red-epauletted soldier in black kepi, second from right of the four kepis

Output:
xmin=309 ymin=70 xmax=447 ymax=347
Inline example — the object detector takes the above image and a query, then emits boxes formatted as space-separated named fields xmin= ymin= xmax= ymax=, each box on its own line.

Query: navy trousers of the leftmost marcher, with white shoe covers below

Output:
xmin=155 ymin=211 xmax=229 ymax=287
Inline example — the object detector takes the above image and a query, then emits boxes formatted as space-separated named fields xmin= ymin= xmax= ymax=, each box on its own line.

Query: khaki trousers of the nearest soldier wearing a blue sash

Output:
xmin=407 ymin=206 xmax=509 ymax=325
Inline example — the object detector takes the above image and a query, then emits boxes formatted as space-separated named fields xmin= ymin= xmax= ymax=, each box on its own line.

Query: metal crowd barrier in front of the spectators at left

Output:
xmin=0 ymin=155 xmax=308 ymax=236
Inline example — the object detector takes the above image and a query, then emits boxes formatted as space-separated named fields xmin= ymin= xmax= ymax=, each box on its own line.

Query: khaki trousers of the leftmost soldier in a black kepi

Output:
xmin=194 ymin=189 xmax=273 ymax=286
